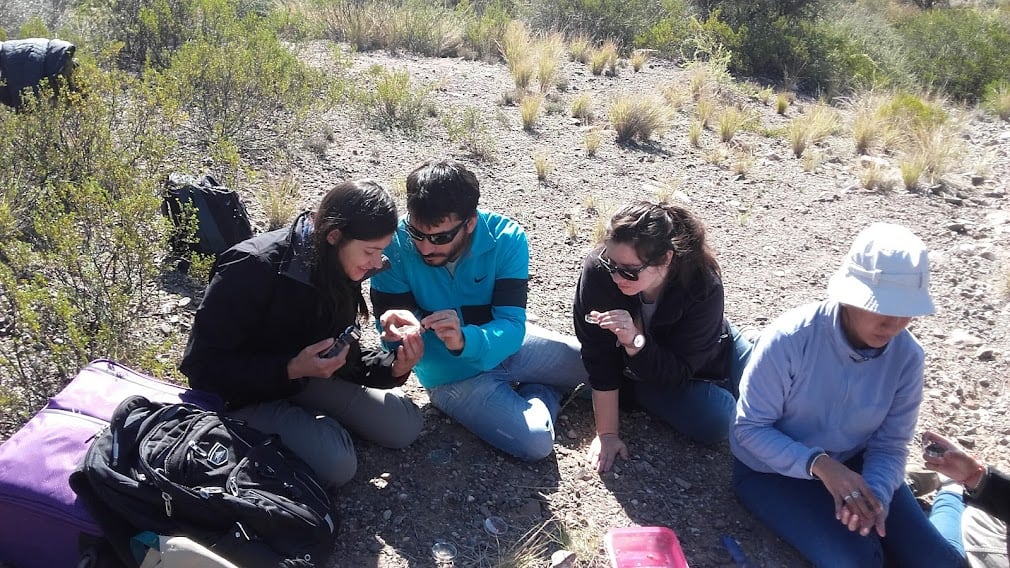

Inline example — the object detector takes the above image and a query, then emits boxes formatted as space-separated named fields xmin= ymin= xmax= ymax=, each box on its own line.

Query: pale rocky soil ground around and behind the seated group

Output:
xmin=7 ymin=28 xmax=1010 ymax=568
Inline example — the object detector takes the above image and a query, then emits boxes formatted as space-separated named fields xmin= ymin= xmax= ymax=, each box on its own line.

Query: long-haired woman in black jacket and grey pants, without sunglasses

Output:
xmin=180 ymin=180 xmax=424 ymax=486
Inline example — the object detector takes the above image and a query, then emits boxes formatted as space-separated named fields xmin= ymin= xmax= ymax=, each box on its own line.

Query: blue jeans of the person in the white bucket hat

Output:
xmin=733 ymin=457 xmax=965 ymax=568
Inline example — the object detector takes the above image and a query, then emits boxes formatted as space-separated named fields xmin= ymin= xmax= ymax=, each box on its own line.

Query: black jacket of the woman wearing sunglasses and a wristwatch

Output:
xmin=574 ymin=243 xmax=733 ymax=390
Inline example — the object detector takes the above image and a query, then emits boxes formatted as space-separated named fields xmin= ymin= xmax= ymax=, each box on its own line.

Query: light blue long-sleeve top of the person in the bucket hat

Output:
xmin=729 ymin=301 xmax=924 ymax=510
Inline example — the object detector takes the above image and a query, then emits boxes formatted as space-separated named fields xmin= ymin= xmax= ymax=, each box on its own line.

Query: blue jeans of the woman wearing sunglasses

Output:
xmin=634 ymin=325 xmax=753 ymax=444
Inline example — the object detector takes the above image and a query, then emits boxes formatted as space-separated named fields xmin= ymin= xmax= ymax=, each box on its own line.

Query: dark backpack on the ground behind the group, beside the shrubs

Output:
xmin=162 ymin=173 xmax=253 ymax=259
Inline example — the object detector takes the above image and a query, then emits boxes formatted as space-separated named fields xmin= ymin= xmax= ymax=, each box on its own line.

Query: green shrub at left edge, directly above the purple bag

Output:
xmin=0 ymin=179 xmax=167 ymax=417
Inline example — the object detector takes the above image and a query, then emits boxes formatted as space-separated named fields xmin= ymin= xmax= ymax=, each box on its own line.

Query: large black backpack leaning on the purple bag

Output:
xmin=71 ymin=396 xmax=337 ymax=566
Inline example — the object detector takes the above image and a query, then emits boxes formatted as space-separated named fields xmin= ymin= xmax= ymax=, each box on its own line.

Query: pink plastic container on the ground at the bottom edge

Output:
xmin=604 ymin=527 xmax=688 ymax=568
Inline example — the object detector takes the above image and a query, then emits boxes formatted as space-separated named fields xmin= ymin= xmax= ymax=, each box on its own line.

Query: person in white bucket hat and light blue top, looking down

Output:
xmin=729 ymin=223 xmax=964 ymax=568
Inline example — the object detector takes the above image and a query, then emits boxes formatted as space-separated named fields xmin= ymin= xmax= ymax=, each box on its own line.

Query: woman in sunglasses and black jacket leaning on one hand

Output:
xmin=575 ymin=202 xmax=750 ymax=471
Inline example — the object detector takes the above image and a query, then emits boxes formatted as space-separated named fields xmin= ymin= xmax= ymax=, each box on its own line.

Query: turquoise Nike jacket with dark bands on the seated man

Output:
xmin=371 ymin=209 xmax=529 ymax=388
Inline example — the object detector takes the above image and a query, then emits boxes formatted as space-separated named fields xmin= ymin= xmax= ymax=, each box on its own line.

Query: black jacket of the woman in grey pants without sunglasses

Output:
xmin=179 ymin=213 xmax=396 ymax=408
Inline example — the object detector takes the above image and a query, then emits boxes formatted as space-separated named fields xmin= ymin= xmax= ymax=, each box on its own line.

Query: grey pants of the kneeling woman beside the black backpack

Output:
xmin=231 ymin=379 xmax=422 ymax=487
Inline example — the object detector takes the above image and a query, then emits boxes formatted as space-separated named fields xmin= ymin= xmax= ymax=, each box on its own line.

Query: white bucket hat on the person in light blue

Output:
xmin=827 ymin=222 xmax=935 ymax=317
